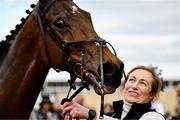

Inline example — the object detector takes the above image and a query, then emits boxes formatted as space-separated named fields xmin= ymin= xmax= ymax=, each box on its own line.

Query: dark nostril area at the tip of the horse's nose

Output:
xmin=98 ymin=62 xmax=124 ymax=88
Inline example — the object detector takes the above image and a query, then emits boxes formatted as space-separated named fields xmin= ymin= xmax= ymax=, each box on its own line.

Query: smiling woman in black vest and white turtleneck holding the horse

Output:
xmin=64 ymin=66 xmax=165 ymax=120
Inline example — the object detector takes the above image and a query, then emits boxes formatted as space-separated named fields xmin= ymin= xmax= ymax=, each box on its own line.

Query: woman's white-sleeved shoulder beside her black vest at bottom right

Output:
xmin=140 ymin=111 xmax=165 ymax=120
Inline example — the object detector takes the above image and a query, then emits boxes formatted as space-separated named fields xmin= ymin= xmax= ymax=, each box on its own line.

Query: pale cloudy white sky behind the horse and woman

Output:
xmin=0 ymin=0 xmax=180 ymax=80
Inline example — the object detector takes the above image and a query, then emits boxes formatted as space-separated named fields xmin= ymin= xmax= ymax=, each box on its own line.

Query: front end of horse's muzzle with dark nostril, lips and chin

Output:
xmin=85 ymin=62 xmax=124 ymax=95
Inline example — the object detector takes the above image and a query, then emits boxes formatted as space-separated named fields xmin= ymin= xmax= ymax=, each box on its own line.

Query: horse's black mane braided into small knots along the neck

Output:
xmin=0 ymin=4 xmax=35 ymax=56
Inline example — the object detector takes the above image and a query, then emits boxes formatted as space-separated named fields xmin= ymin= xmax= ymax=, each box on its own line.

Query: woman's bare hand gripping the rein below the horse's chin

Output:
xmin=63 ymin=101 xmax=89 ymax=120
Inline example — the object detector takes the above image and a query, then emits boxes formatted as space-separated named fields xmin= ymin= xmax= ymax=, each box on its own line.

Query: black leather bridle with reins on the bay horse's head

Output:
xmin=36 ymin=0 xmax=125 ymax=119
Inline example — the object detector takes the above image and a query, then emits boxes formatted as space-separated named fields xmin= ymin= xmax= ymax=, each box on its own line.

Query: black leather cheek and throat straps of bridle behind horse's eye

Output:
xmin=36 ymin=0 xmax=77 ymax=89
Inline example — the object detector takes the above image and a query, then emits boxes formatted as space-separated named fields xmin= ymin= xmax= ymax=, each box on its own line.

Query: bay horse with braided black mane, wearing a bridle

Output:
xmin=0 ymin=0 xmax=124 ymax=119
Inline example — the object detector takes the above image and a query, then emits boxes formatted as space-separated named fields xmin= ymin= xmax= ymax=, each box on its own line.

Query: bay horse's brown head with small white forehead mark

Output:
xmin=36 ymin=0 xmax=124 ymax=94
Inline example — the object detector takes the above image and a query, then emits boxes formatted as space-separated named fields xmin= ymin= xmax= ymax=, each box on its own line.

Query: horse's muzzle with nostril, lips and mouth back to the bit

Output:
xmin=76 ymin=62 xmax=124 ymax=95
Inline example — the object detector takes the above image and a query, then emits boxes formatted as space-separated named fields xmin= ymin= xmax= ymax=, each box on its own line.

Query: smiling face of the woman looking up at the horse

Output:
xmin=124 ymin=69 xmax=153 ymax=104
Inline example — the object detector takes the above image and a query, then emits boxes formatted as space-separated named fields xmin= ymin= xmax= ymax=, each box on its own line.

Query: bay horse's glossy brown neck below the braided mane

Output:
xmin=0 ymin=13 xmax=49 ymax=118
